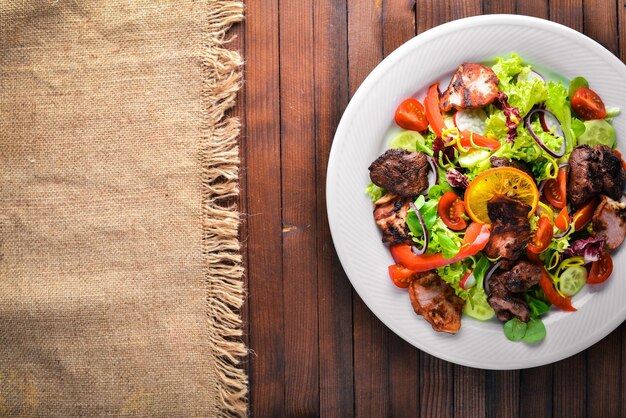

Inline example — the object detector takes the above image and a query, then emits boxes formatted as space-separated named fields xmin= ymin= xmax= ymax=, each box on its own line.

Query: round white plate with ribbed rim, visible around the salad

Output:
xmin=327 ymin=15 xmax=626 ymax=369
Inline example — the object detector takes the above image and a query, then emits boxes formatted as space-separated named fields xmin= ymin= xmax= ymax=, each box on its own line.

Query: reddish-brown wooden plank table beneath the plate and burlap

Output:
xmin=233 ymin=0 xmax=626 ymax=418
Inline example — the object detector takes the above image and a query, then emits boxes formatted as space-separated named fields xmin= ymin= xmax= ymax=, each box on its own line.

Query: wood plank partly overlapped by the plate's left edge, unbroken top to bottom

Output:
xmin=313 ymin=0 xmax=354 ymax=417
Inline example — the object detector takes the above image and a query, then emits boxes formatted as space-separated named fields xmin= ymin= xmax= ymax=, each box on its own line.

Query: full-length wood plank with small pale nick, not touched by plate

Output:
xmin=279 ymin=1 xmax=319 ymax=417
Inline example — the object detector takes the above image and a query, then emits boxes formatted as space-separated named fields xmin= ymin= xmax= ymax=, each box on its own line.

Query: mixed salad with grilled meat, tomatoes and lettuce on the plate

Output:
xmin=366 ymin=54 xmax=626 ymax=343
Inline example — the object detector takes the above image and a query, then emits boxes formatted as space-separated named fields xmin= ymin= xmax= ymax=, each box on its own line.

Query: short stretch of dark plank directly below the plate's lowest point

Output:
xmin=485 ymin=370 xmax=520 ymax=418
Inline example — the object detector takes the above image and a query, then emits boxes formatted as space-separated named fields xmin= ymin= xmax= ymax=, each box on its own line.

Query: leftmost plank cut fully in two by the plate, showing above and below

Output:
xmin=348 ymin=0 xmax=389 ymax=417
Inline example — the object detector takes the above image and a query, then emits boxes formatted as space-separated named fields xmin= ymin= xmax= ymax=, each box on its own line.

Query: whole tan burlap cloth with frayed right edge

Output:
xmin=0 ymin=0 xmax=247 ymax=417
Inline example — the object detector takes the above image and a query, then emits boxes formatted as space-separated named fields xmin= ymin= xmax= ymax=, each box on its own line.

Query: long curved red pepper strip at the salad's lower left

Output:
xmin=389 ymin=222 xmax=491 ymax=272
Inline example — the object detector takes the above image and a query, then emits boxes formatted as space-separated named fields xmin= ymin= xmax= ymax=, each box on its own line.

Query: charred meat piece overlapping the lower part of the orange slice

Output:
xmin=484 ymin=196 xmax=531 ymax=260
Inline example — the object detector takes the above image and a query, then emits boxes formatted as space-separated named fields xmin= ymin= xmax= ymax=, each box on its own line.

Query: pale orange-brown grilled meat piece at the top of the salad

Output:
xmin=439 ymin=62 xmax=499 ymax=112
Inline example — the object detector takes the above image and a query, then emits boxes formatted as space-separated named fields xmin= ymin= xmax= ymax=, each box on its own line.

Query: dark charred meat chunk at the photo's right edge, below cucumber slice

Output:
xmin=567 ymin=145 xmax=626 ymax=208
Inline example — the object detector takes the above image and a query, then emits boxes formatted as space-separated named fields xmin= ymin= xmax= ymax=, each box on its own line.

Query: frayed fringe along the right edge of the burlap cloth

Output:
xmin=201 ymin=0 xmax=248 ymax=416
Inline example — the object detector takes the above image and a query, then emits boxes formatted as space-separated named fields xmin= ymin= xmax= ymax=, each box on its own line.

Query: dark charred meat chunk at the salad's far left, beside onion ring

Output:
xmin=369 ymin=149 xmax=430 ymax=197
